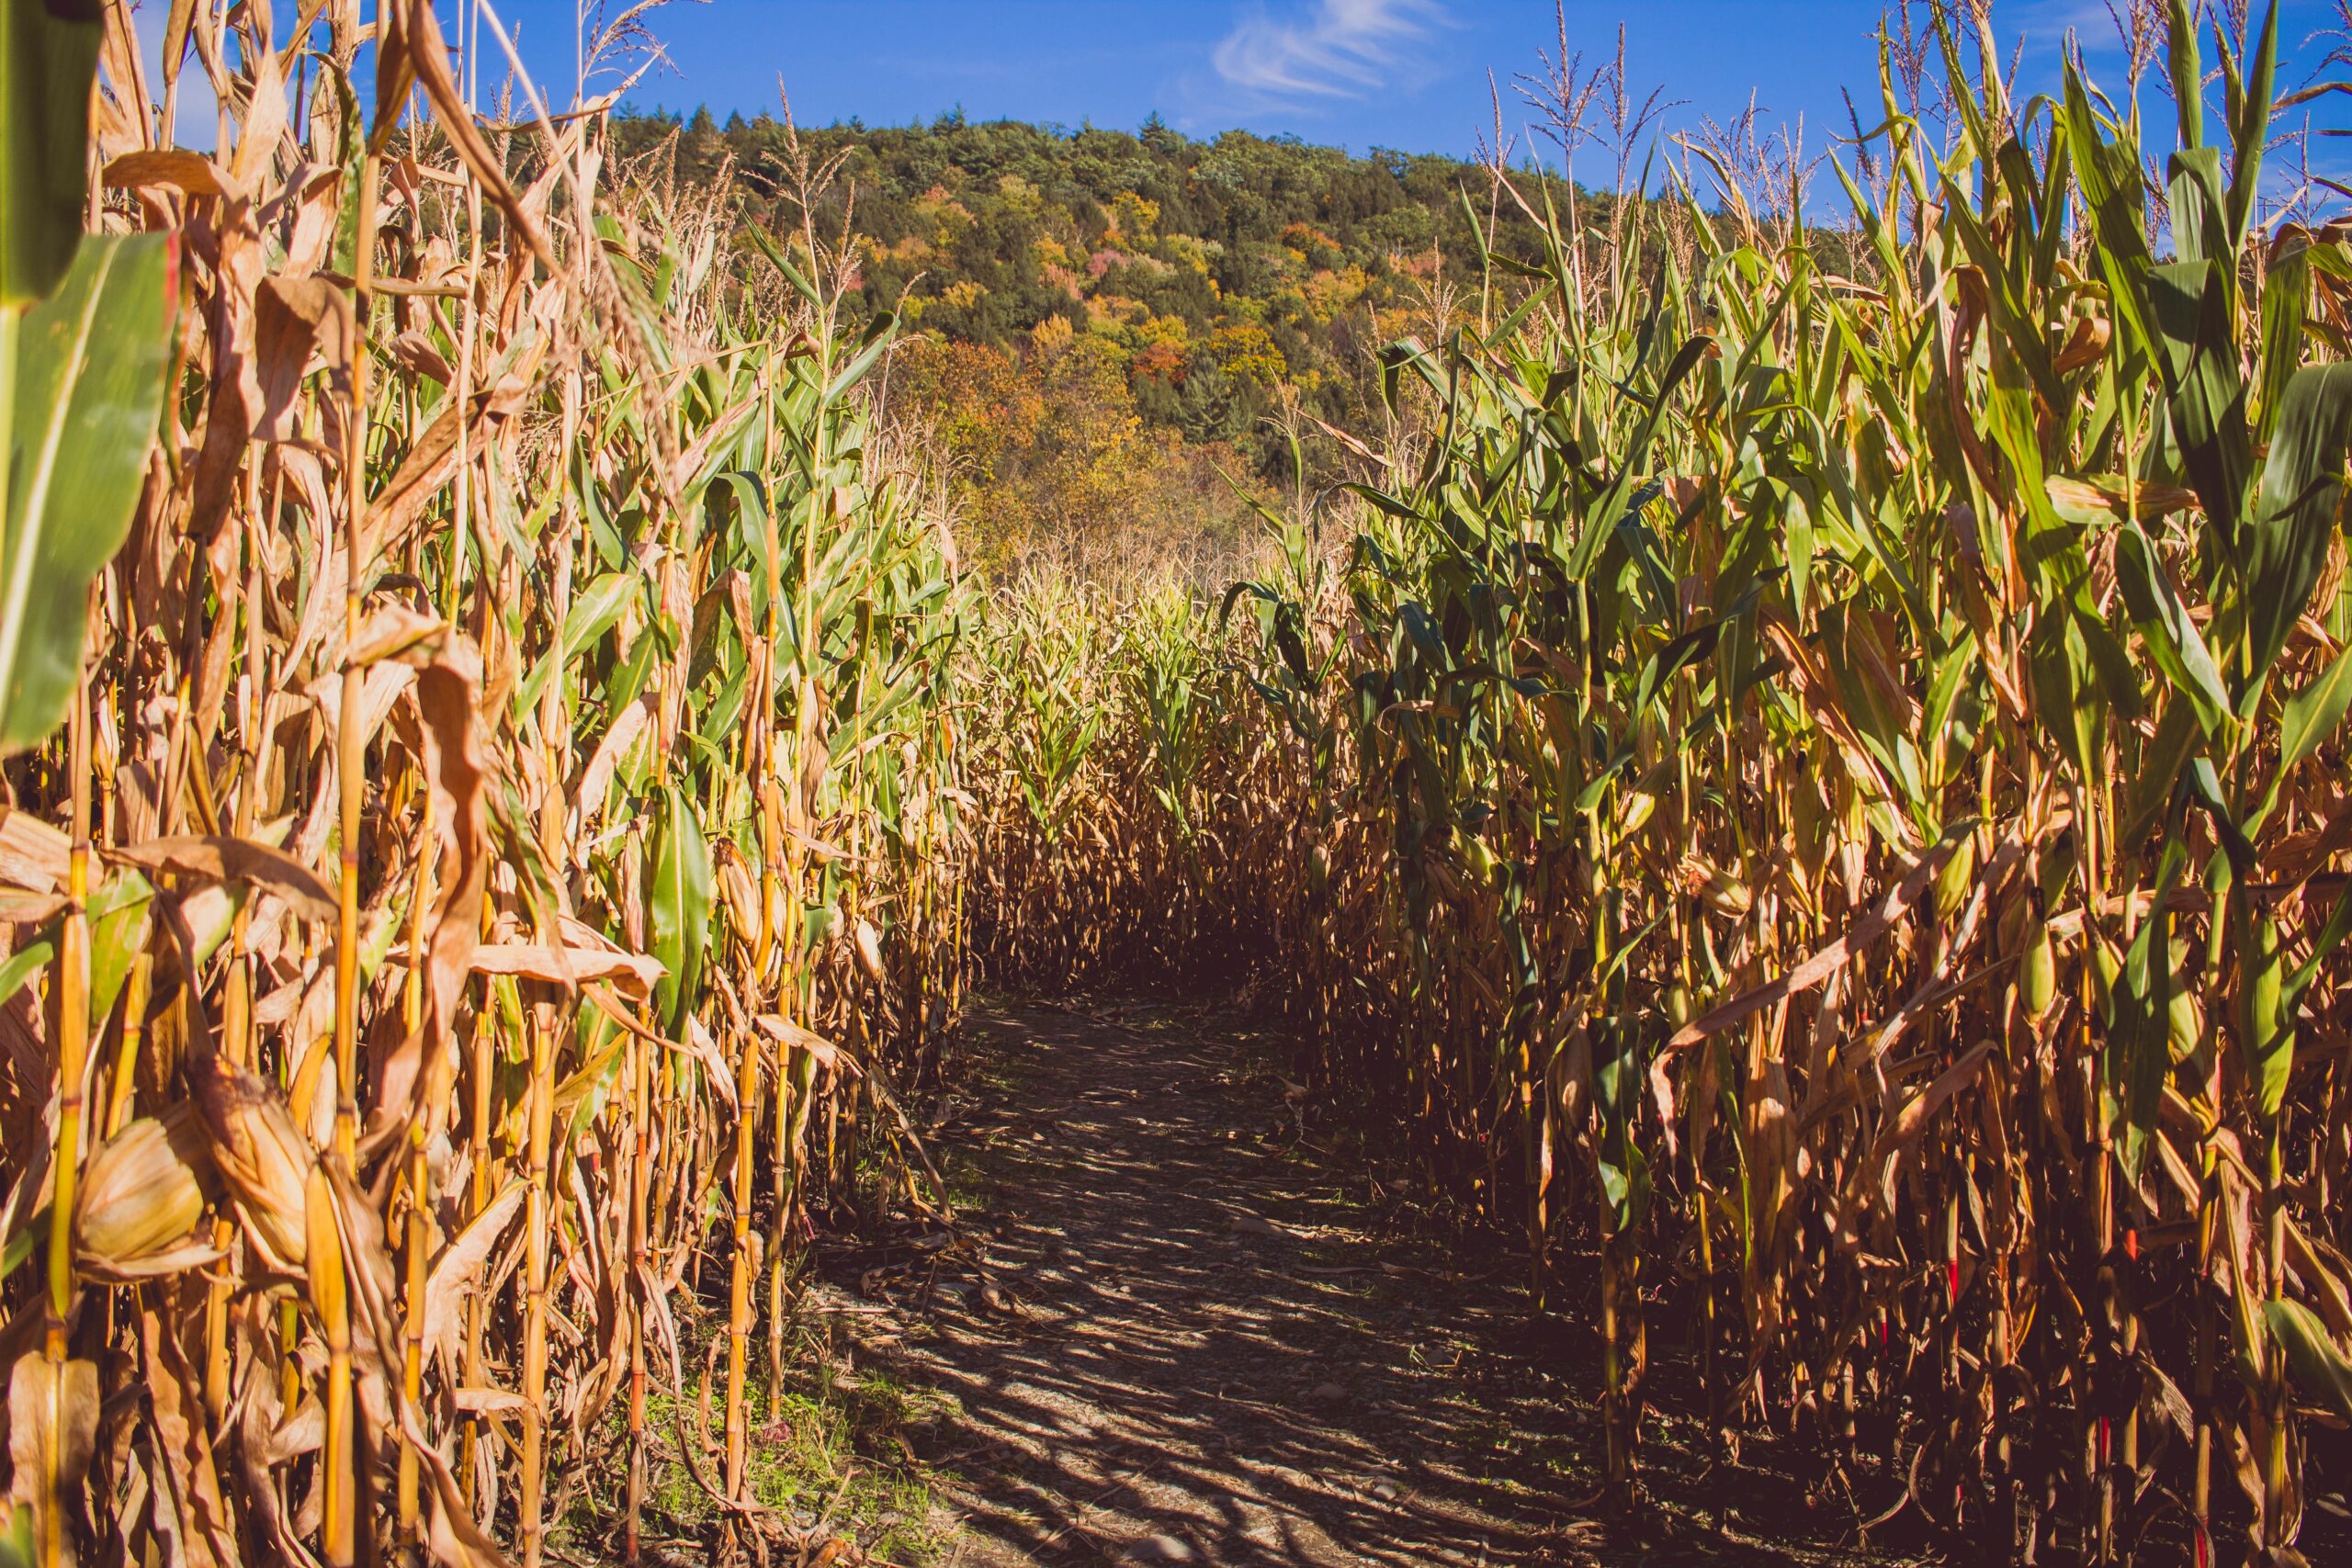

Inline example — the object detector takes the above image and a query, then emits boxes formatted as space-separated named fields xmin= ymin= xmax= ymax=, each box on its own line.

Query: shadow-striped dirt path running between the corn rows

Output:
xmin=828 ymin=1006 xmax=1862 ymax=1568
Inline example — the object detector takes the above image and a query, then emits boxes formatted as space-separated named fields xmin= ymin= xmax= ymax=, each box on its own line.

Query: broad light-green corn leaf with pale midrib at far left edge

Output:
xmin=0 ymin=231 xmax=174 ymax=752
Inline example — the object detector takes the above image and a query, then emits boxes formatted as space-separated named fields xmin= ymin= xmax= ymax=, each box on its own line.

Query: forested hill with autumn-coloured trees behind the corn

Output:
xmin=614 ymin=110 xmax=1589 ymax=570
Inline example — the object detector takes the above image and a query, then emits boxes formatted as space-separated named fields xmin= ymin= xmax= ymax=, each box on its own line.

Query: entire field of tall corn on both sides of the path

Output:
xmin=14 ymin=0 xmax=2352 ymax=1568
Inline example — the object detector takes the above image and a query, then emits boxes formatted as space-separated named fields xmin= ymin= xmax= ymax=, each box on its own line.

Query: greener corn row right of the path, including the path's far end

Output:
xmin=978 ymin=3 xmax=2352 ymax=1561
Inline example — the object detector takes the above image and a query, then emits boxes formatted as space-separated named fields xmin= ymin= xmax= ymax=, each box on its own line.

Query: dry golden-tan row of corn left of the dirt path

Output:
xmin=0 ymin=0 xmax=974 ymax=1568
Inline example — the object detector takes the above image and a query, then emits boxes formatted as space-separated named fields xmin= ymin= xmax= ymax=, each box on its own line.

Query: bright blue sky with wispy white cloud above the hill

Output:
xmin=136 ymin=0 xmax=2352 ymax=179
